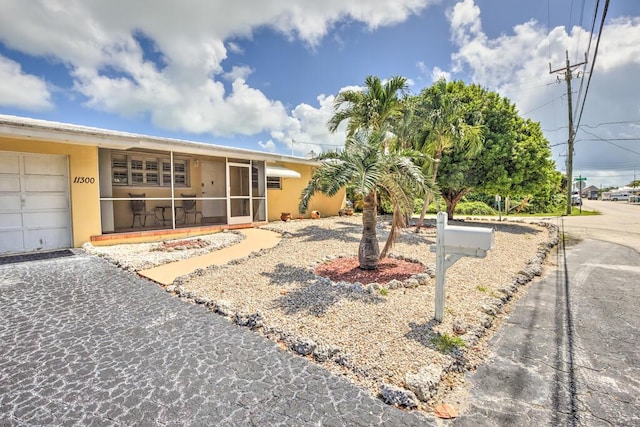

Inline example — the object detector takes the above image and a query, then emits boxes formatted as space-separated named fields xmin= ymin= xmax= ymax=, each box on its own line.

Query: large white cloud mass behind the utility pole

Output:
xmin=448 ymin=0 xmax=640 ymax=185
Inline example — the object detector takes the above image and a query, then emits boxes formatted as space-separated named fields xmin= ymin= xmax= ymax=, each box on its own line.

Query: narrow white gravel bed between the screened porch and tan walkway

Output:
xmin=83 ymin=231 xmax=244 ymax=271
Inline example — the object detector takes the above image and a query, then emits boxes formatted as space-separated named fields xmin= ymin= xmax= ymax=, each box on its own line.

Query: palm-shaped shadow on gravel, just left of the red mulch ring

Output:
xmin=262 ymin=264 xmax=384 ymax=316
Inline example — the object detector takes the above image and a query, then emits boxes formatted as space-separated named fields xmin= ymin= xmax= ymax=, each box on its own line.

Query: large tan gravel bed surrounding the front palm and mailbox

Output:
xmin=90 ymin=215 xmax=557 ymax=411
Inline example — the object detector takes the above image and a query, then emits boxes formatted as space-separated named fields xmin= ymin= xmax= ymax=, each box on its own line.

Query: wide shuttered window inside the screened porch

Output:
xmin=111 ymin=153 xmax=189 ymax=187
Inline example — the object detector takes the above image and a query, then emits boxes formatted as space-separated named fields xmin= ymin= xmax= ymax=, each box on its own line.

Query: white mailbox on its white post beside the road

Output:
xmin=431 ymin=212 xmax=494 ymax=322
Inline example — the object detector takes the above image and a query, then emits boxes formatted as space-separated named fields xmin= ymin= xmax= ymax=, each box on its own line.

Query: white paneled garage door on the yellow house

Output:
xmin=0 ymin=151 xmax=71 ymax=253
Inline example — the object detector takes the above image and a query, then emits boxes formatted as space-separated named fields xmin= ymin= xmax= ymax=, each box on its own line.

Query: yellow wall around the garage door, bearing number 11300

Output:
xmin=0 ymin=138 xmax=101 ymax=247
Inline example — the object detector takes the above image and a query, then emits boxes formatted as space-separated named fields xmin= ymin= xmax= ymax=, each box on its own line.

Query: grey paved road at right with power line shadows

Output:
xmin=455 ymin=206 xmax=640 ymax=426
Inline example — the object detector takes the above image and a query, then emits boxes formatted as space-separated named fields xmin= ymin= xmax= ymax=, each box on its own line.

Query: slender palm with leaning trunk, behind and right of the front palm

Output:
xmin=415 ymin=79 xmax=484 ymax=228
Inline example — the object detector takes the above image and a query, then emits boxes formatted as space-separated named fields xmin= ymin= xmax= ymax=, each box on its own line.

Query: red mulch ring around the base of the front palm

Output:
xmin=315 ymin=257 xmax=425 ymax=284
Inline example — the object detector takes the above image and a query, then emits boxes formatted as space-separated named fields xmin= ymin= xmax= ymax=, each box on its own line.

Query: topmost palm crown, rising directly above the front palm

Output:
xmin=327 ymin=76 xmax=407 ymax=136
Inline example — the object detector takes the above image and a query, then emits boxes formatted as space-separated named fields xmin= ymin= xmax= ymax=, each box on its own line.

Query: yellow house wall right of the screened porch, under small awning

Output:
xmin=267 ymin=163 xmax=346 ymax=221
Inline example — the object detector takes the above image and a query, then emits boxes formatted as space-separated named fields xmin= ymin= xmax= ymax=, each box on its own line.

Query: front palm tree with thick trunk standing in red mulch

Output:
xmin=298 ymin=129 xmax=425 ymax=270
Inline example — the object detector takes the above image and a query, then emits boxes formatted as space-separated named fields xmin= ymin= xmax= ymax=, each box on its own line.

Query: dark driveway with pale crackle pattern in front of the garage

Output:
xmin=0 ymin=254 xmax=431 ymax=426
